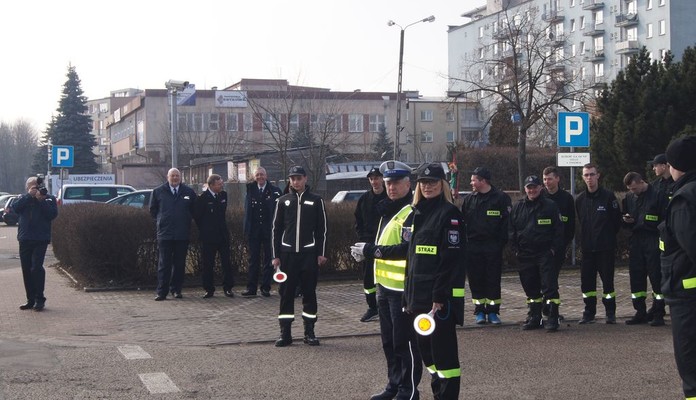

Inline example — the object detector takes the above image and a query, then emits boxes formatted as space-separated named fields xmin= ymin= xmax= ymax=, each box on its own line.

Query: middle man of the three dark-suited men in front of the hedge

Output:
xmin=193 ymin=174 xmax=234 ymax=299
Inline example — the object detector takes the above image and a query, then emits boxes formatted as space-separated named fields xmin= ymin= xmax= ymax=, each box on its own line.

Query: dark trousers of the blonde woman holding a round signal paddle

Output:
xmin=417 ymin=303 xmax=461 ymax=400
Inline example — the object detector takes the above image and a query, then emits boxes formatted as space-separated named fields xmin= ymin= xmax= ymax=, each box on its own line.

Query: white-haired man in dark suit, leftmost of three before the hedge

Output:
xmin=150 ymin=168 xmax=196 ymax=301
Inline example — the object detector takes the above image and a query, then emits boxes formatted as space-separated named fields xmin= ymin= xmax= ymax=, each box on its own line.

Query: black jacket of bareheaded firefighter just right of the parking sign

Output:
xmin=575 ymin=187 xmax=621 ymax=251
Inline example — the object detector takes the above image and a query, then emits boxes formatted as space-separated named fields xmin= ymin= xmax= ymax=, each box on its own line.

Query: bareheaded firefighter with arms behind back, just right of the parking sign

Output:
xmin=575 ymin=164 xmax=621 ymax=324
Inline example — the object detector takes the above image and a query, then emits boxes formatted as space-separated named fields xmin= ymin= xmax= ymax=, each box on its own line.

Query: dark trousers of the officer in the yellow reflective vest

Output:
xmin=377 ymin=285 xmax=423 ymax=399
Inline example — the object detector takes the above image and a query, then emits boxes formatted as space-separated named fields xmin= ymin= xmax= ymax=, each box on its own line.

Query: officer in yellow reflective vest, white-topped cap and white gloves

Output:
xmin=351 ymin=161 xmax=423 ymax=400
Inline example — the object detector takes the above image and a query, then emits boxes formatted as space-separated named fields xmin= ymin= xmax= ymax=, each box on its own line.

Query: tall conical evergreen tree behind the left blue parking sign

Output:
xmin=43 ymin=65 xmax=98 ymax=174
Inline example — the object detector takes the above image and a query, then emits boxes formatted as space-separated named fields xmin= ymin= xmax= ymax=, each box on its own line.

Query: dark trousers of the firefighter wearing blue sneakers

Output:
xmin=465 ymin=251 xmax=503 ymax=314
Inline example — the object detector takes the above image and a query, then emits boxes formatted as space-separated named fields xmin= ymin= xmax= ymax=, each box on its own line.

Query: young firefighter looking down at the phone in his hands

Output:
xmin=621 ymin=172 xmax=667 ymax=326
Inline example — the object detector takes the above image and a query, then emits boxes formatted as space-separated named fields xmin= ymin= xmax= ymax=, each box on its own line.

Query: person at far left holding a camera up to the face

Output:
xmin=12 ymin=176 xmax=58 ymax=311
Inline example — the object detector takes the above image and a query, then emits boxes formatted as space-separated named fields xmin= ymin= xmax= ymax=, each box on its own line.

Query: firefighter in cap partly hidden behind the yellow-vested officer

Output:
xmin=355 ymin=167 xmax=387 ymax=322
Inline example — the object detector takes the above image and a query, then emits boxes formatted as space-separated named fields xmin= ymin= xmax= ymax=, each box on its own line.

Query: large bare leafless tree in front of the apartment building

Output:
xmin=449 ymin=5 xmax=592 ymax=190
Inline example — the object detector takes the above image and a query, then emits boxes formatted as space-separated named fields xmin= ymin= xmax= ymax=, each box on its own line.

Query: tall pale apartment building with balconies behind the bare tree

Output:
xmin=448 ymin=0 xmax=696 ymax=91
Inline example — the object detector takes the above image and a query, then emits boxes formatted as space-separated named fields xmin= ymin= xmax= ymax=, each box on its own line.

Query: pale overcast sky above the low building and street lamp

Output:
xmin=0 ymin=0 xmax=486 ymax=132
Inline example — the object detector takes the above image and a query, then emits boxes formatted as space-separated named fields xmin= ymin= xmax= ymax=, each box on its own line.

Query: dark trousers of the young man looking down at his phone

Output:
xmin=628 ymin=233 xmax=662 ymax=294
